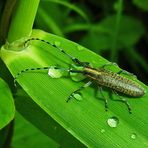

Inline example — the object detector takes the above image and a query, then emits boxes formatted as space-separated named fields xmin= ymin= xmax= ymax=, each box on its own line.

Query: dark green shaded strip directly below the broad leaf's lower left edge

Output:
xmin=15 ymin=90 xmax=84 ymax=147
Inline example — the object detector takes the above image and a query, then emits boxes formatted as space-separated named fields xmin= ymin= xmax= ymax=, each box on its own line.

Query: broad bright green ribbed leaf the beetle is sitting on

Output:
xmin=2 ymin=30 xmax=148 ymax=148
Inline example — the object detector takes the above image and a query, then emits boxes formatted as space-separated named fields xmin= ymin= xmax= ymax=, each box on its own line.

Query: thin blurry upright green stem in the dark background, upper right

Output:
xmin=110 ymin=0 xmax=123 ymax=62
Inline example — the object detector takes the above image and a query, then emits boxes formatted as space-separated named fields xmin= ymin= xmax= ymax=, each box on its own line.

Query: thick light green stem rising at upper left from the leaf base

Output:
xmin=8 ymin=0 xmax=40 ymax=42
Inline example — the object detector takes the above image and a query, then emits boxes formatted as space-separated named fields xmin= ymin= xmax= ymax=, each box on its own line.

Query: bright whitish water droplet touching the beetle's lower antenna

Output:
xmin=48 ymin=66 xmax=63 ymax=78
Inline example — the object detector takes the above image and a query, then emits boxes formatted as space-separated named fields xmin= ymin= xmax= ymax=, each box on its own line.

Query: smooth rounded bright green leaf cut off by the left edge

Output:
xmin=0 ymin=78 xmax=15 ymax=129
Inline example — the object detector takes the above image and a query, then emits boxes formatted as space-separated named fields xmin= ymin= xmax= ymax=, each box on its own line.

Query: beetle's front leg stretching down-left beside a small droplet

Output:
xmin=66 ymin=81 xmax=92 ymax=102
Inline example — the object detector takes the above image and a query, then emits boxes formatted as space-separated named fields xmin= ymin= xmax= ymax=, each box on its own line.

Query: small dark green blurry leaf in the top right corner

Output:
xmin=133 ymin=0 xmax=148 ymax=11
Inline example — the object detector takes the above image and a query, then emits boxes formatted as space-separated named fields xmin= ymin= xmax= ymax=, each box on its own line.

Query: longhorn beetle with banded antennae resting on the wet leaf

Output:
xmin=14 ymin=38 xmax=145 ymax=113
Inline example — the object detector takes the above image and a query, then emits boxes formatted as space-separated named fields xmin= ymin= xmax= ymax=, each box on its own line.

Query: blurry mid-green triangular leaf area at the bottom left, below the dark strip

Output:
xmin=11 ymin=113 xmax=59 ymax=148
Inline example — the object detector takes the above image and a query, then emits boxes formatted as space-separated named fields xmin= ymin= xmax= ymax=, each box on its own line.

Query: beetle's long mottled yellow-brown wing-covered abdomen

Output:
xmin=84 ymin=69 xmax=144 ymax=97
